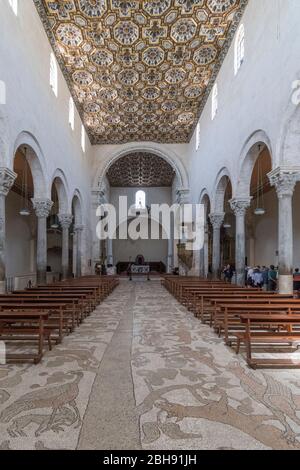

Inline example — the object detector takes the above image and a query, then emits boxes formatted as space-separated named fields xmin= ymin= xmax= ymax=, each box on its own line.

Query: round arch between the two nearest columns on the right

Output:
xmin=233 ymin=130 xmax=273 ymax=198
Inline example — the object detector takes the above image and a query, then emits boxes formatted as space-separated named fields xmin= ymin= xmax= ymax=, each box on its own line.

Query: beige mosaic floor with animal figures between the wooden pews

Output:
xmin=0 ymin=281 xmax=300 ymax=450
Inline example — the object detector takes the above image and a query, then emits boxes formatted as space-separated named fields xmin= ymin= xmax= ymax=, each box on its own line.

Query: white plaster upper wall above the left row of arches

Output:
xmin=0 ymin=0 xmax=91 ymax=271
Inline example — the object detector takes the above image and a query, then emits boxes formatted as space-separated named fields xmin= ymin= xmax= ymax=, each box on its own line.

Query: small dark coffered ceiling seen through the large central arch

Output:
xmin=106 ymin=152 xmax=175 ymax=188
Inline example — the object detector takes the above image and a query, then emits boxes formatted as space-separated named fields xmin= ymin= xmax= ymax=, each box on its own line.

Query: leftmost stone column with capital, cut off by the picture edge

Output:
xmin=0 ymin=168 xmax=17 ymax=294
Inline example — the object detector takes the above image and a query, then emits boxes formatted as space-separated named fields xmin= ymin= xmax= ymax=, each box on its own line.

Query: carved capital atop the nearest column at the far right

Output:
xmin=268 ymin=167 xmax=300 ymax=198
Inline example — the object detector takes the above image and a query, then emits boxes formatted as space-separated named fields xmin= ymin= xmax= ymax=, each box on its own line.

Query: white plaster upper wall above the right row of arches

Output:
xmin=188 ymin=0 xmax=300 ymax=206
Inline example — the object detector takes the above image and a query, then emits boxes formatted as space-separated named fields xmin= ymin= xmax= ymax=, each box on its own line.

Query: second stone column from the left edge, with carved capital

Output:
xmin=32 ymin=199 xmax=53 ymax=284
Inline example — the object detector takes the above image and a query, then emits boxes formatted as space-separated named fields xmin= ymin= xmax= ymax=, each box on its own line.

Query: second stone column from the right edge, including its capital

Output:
xmin=230 ymin=197 xmax=251 ymax=286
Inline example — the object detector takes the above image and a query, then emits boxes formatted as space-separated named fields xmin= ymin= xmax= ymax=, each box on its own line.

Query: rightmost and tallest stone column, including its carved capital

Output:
xmin=268 ymin=168 xmax=299 ymax=294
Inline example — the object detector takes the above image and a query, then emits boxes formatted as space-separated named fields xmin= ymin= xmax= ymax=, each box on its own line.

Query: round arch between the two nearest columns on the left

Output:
xmin=10 ymin=131 xmax=47 ymax=199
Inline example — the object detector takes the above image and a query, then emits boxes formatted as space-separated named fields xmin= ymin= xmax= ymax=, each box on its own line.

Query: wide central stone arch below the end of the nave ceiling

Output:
xmin=94 ymin=144 xmax=189 ymax=189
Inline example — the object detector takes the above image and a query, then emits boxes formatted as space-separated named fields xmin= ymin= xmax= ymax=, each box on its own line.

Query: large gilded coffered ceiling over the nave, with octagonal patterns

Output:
xmin=34 ymin=0 xmax=248 ymax=144
